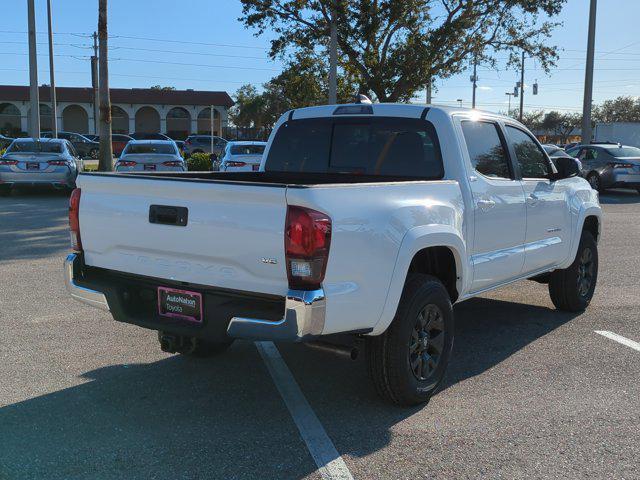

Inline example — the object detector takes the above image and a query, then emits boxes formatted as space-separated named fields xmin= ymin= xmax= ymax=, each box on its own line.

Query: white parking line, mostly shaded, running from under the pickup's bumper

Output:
xmin=255 ymin=342 xmax=353 ymax=480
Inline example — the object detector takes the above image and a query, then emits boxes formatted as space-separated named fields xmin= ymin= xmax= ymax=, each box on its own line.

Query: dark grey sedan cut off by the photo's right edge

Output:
xmin=567 ymin=143 xmax=640 ymax=193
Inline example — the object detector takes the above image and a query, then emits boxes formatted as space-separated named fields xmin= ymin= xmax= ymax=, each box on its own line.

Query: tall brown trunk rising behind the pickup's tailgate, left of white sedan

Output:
xmin=98 ymin=0 xmax=113 ymax=172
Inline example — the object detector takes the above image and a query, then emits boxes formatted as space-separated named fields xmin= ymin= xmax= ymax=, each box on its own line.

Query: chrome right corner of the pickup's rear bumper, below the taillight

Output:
xmin=227 ymin=288 xmax=326 ymax=342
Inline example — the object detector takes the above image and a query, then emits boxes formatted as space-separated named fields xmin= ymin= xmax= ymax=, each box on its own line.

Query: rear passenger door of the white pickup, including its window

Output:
xmin=461 ymin=120 xmax=526 ymax=292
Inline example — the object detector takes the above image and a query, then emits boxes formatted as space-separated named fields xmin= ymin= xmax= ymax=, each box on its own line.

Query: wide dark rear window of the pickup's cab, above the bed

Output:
xmin=265 ymin=117 xmax=444 ymax=179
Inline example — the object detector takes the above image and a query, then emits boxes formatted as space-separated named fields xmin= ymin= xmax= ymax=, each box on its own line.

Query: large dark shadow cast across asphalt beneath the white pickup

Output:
xmin=0 ymin=298 xmax=573 ymax=479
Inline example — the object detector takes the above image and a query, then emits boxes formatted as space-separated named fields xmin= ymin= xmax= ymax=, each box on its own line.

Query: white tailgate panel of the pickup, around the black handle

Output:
xmin=77 ymin=175 xmax=288 ymax=295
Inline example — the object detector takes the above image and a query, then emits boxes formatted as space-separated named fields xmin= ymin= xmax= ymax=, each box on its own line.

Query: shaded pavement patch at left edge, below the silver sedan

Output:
xmin=0 ymin=189 xmax=69 ymax=262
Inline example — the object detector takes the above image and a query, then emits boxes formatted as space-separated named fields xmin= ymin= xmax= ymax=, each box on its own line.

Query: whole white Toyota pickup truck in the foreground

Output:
xmin=65 ymin=103 xmax=601 ymax=405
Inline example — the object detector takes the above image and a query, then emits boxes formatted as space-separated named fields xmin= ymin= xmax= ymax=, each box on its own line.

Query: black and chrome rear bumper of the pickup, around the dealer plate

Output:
xmin=64 ymin=254 xmax=326 ymax=342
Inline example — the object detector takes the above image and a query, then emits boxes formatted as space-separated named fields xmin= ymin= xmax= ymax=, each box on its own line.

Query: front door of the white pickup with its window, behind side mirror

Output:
xmin=505 ymin=125 xmax=570 ymax=273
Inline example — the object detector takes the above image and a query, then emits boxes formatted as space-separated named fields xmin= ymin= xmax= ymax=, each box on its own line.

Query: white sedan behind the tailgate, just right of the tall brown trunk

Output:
xmin=115 ymin=140 xmax=187 ymax=172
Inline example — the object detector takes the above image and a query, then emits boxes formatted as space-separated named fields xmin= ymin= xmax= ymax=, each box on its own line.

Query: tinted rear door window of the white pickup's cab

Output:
xmin=462 ymin=121 xmax=511 ymax=178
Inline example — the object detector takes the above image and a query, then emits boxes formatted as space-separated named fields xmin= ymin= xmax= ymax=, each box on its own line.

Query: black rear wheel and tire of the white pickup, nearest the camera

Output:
xmin=366 ymin=274 xmax=454 ymax=406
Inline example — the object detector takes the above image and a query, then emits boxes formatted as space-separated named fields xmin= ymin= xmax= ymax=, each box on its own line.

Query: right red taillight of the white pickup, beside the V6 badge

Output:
xmin=284 ymin=205 xmax=331 ymax=290
